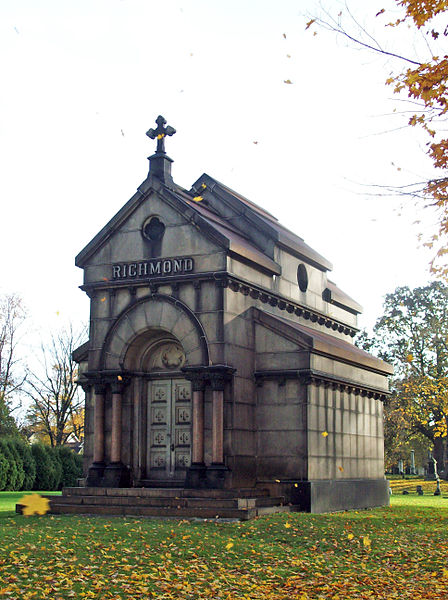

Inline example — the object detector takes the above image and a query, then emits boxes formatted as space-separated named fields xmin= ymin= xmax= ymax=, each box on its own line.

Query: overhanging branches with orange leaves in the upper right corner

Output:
xmin=307 ymin=0 xmax=448 ymax=277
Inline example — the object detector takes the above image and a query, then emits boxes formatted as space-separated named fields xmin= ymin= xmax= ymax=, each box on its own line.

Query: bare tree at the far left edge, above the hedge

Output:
xmin=0 ymin=294 xmax=25 ymax=435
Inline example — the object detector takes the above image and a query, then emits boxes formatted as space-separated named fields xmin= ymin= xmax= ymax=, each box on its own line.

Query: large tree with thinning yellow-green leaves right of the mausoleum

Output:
xmin=362 ymin=282 xmax=448 ymax=470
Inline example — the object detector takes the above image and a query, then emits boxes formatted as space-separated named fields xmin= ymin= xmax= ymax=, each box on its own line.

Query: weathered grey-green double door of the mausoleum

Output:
xmin=146 ymin=378 xmax=192 ymax=481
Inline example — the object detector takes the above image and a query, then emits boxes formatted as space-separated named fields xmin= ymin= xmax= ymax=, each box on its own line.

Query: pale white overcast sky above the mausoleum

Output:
xmin=0 ymin=0 xmax=438 ymax=354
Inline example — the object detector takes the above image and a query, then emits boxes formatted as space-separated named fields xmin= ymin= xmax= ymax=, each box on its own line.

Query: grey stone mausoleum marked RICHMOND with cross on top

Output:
xmin=66 ymin=117 xmax=392 ymax=512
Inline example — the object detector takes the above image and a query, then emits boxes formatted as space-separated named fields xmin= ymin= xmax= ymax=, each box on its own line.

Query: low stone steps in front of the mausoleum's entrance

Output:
xmin=39 ymin=487 xmax=297 ymax=521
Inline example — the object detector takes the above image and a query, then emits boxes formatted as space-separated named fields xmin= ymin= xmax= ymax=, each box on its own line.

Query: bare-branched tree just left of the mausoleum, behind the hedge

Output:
xmin=26 ymin=327 xmax=85 ymax=446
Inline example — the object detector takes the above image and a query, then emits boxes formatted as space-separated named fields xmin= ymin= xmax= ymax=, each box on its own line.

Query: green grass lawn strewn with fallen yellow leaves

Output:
xmin=0 ymin=487 xmax=448 ymax=600
